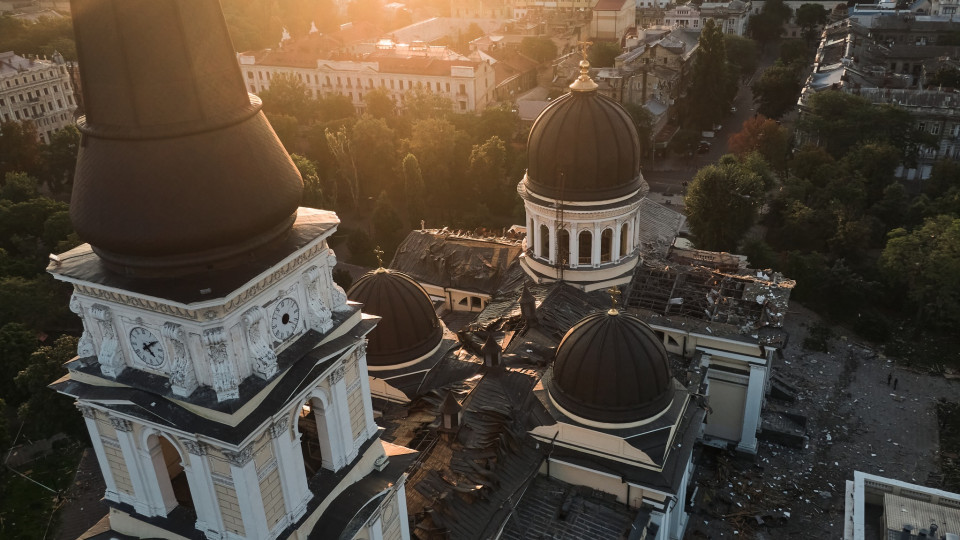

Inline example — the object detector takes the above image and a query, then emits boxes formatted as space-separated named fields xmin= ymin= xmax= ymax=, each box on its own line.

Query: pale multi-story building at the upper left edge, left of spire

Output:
xmin=0 ymin=51 xmax=77 ymax=143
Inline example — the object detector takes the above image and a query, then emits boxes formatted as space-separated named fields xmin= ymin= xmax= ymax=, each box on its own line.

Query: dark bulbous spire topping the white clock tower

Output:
xmin=70 ymin=0 xmax=303 ymax=275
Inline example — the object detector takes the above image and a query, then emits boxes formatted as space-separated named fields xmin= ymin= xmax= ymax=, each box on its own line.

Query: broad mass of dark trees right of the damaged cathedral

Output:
xmin=686 ymin=92 xmax=960 ymax=356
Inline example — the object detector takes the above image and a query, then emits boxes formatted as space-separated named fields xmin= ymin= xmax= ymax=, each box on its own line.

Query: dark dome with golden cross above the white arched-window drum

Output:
xmin=527 ymin=90 xmax=644 ymax=201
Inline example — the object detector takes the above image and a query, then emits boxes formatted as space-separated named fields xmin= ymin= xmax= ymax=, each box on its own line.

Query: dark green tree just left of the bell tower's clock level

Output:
xmin=15 ymin=336 xmax=86 ymax=438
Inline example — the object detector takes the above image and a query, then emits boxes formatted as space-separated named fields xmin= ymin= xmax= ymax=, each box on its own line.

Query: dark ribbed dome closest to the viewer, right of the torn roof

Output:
xmin=549 ymin=310 xmax=673 ymax=424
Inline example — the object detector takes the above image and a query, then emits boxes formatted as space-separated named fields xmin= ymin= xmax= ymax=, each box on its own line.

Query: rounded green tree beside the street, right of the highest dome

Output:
xmin=684 ymin=157 xmax=763 ymax=251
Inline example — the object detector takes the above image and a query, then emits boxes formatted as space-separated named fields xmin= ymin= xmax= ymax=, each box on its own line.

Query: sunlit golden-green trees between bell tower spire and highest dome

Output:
xmin=261 ymin=76 xmax=524 ymax=264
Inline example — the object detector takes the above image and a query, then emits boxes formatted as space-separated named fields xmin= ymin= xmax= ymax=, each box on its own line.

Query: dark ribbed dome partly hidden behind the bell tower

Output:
xmin=347 ymin=268 xmax=443 ymax=366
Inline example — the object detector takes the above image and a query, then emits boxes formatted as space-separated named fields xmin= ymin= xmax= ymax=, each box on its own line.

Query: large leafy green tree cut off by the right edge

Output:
xmin=880 ymin=216 xmax=960 ymax=329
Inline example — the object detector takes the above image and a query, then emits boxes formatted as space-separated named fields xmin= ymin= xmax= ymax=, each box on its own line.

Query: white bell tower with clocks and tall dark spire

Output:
xmin=48 ymin=0 xmax=409 ymax=539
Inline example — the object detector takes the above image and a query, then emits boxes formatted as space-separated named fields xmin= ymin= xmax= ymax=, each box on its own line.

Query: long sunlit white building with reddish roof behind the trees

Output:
xmin=239 ymin=40 xmax=496 ymax=112
